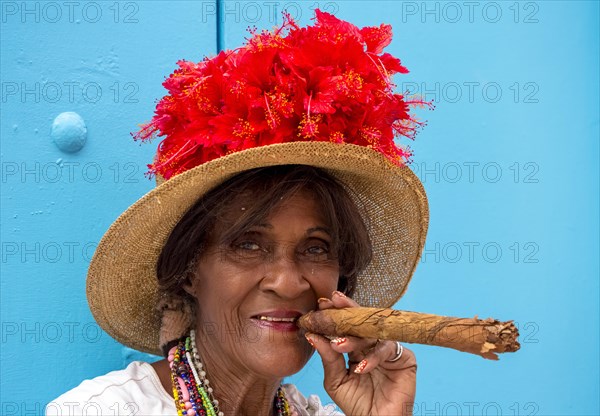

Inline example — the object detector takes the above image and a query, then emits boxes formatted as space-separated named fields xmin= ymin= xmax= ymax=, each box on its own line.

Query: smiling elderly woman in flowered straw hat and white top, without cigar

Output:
xmin=47 ymin=10 xmax=428 ymax=416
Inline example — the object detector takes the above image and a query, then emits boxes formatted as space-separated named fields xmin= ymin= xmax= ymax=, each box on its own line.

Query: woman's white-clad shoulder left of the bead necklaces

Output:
xmin=46 ymin=361 xmax=175 ymax=416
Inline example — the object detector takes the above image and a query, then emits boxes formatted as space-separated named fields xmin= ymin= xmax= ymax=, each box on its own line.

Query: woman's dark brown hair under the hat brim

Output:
xmin=156 ymin=165 xmax=372 ymax=304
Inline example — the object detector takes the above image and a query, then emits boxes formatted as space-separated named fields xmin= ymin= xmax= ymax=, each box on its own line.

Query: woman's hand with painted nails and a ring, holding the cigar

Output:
xmin=306 ymin=292 xmax=417 ymax=416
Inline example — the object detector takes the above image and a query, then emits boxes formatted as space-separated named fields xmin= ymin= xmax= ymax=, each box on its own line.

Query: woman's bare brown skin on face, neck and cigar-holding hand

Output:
xmin=154 ymin=192 xmax=416 ymax=415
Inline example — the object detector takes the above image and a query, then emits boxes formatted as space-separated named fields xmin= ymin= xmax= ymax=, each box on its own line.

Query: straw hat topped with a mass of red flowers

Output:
xmin=87 ymin=10 xmax=429 ymax=355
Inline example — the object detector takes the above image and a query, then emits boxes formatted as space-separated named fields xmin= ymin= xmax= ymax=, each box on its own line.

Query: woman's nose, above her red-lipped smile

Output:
xmin=259 ymin=250 xmax=310 ymax=299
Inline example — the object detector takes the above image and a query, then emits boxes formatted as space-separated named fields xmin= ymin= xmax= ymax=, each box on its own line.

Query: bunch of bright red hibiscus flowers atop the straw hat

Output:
xmin=134 ymin=9 xmax=432 ymax=179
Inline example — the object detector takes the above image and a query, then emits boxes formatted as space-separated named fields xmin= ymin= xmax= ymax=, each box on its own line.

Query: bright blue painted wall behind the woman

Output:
xmin=0 ymin=1 xmax=600 ymax=415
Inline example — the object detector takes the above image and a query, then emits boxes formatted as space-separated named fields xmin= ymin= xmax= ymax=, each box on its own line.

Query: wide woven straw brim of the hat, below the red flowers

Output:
xmin=87 ymin=142 xmax=429 ymax=355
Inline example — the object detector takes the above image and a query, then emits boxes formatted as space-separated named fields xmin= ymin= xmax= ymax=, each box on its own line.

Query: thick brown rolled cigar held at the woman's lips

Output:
xmin=298 ymin=308 xmax=520 ymax=360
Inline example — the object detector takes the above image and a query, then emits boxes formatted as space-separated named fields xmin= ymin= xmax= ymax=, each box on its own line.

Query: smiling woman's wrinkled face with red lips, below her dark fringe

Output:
xmin=189 ymin=192 xmax=339 ymax=377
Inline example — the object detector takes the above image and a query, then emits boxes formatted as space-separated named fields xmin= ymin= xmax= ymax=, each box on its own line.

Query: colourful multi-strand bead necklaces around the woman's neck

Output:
xmin=168 ymin=330 xmax=290 ymax=416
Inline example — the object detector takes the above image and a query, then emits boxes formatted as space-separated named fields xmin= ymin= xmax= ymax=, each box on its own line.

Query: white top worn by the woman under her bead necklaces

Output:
xmin=46 ymin=361 xmax=343 ymax=416
